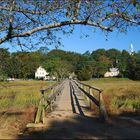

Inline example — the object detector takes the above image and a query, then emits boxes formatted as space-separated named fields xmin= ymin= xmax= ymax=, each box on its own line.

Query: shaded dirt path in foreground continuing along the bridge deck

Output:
xmin=17 ymin=80 xmax=140 ymax=139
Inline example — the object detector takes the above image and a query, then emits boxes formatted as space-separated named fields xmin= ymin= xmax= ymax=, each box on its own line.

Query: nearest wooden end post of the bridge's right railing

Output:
xmin=99 ymin=92 xmax=108 ymax=121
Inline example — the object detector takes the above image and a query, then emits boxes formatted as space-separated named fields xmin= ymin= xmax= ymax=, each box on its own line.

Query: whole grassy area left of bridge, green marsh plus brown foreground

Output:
xmin=0 ymin=80 xmax=56 ymax=137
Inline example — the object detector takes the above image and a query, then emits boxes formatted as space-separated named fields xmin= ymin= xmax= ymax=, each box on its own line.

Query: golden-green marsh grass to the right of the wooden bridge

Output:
xmin=83 ymin=78 xmax=140 ymax=114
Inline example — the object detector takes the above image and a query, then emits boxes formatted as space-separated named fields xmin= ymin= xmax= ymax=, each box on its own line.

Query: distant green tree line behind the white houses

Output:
xmin=0 ymin=48 xmax=140 ymax=80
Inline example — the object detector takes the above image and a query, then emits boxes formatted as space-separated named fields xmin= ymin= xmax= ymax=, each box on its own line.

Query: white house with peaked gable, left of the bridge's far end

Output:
xmin=35 ymin=66 xmax=50 ymax=80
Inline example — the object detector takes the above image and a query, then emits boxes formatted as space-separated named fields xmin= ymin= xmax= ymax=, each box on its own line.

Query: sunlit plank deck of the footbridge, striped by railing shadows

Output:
xmin=51 ymin=80 xmax=89 ymax=116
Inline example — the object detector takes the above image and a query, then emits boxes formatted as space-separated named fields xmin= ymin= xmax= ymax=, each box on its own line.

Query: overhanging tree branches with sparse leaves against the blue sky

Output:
xmin=0 ymin=0 xmax=140 ymax=47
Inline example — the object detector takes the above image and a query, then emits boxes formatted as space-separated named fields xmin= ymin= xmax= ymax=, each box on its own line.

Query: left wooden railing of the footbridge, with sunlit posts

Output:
xmin=27 ymin=82 xmax=63 ymax=127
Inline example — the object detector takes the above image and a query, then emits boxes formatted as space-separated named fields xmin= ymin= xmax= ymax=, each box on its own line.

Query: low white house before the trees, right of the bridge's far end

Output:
xmin=104 ymin=68 xmax=120 ymax=77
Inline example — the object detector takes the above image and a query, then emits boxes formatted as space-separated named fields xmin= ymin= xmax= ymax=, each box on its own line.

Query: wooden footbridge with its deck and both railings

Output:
xmin=27 ymin=80 xmax=108 ymax=127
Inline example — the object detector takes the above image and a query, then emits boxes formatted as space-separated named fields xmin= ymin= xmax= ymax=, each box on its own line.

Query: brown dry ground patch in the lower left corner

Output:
xmin=0 ymin=107 xmax=36 ymax=140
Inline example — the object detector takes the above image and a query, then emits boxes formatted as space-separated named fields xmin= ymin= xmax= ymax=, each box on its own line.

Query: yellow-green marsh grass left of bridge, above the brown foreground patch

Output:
xmin=0 ymin=81 xmax=53 ymax=109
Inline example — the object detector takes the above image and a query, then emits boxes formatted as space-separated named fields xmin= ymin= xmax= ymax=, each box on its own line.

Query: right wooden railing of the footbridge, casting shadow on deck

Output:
xmin=73 ymin=80 xmax=108 ymax=120
